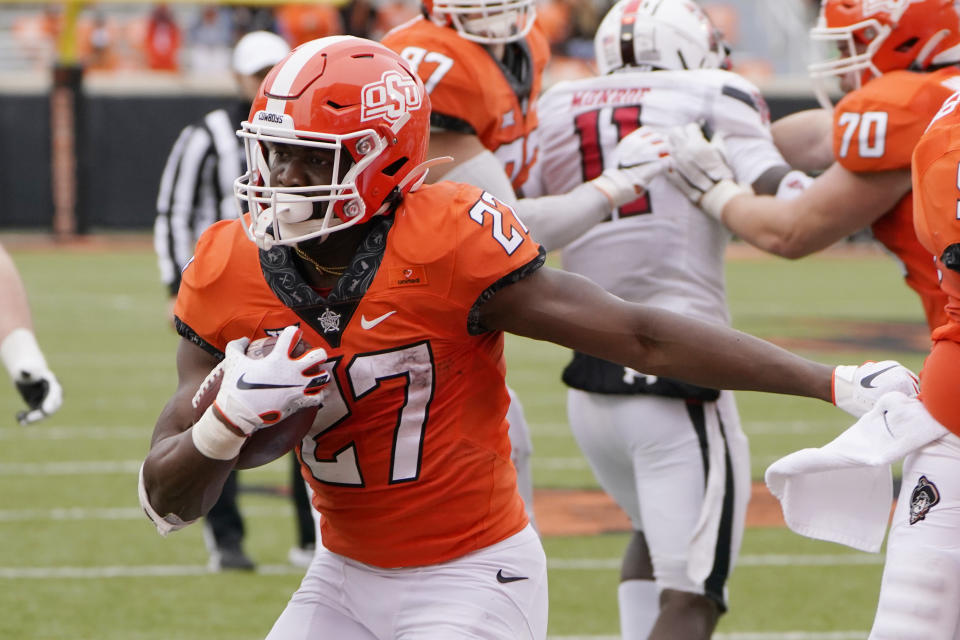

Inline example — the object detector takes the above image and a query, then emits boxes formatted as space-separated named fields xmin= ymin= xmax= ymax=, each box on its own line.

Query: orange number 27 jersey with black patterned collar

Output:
xmin=175 ymin=182 xmax=544 ymax=567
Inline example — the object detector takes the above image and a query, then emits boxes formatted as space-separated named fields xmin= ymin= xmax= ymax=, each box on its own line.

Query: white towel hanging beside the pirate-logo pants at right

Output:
xmin=766 ymin=391 xmax=949 ymax=553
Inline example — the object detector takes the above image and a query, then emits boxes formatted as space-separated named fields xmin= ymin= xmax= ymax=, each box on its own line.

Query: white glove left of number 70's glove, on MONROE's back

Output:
xmin=588 ymin=127 xmax=670 ymax=208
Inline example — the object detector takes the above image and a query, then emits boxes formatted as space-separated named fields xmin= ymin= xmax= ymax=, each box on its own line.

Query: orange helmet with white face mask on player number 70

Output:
xmin=808 ymin=0 xmax=960 ymax=105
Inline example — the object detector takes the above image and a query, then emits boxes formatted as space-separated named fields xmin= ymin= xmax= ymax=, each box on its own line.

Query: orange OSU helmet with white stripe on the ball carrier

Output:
xmin=234 ymin=36 xmax=430 ymax=249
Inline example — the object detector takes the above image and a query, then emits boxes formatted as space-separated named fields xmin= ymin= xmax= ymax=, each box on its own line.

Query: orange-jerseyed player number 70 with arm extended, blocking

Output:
xmin=668 ymin=0 xmax=960 ymax=338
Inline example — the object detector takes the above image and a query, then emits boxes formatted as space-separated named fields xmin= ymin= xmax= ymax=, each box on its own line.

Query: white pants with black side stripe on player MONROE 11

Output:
xmin=567 ymin=389 xmax=750 ymax=607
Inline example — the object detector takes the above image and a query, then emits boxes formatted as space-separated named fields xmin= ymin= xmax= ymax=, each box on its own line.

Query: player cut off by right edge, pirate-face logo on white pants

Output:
xmin=870 ymin=93 xmax=960 ymax=640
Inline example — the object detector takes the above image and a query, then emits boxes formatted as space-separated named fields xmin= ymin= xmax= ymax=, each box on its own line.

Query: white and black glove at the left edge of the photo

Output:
xmin=0 ymin=328 xmax=63 ymax=426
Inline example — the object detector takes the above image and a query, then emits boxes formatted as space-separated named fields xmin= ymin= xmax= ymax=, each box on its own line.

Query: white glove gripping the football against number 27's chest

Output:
xmin=191 ymin=326 xmax=330 ymax=460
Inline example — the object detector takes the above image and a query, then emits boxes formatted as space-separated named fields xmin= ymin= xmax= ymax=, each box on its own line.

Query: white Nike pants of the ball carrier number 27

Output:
xmin=267 ymin=525 xmax=547 ymax=640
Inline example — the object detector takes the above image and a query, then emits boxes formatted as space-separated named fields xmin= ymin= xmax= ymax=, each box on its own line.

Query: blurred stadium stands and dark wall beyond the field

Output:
xmin=0 ymin=0 xmax=816 ymax=238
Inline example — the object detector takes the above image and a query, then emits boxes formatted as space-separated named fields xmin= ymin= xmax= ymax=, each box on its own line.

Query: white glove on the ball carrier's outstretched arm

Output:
xmin=833 ymin=360 xmax=919 ymax=418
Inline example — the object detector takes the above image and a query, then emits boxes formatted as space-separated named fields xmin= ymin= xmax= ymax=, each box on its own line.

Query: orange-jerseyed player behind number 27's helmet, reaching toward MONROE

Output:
xmin=382 ymin=0 xmax=648 ymax=518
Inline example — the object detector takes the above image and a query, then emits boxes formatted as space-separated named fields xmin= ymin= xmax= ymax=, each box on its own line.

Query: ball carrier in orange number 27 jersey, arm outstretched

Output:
xmin=139 ymin=36 xmax=914 ymax=640
